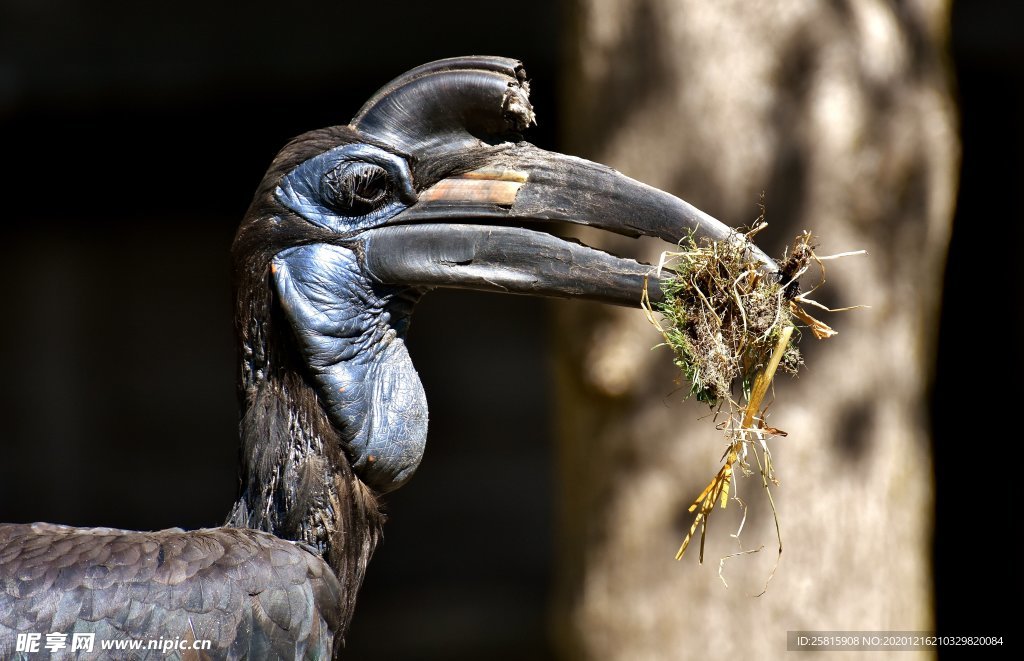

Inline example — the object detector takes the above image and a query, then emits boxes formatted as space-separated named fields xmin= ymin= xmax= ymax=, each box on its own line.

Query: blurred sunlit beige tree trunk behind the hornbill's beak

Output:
xmin=555 ymin=0 xmax=958 ymax=659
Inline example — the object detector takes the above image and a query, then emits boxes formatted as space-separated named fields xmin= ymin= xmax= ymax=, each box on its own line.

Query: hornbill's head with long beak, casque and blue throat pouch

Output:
xmin=233 ymin=57 xmax=776 ymax=503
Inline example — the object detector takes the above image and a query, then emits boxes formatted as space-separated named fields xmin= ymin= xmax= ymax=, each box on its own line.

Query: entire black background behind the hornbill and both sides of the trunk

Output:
xmin=0 ymin=0 xmax=1024 ymax=659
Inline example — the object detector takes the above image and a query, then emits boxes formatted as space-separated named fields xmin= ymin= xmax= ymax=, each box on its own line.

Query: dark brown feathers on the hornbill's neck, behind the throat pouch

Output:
xmin=227 ymin=278 xmax=384 ymax=625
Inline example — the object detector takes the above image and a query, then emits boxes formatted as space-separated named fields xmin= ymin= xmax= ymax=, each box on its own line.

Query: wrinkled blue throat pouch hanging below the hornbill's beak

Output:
xmin=272 ymin=244 xmax=427 ymax=491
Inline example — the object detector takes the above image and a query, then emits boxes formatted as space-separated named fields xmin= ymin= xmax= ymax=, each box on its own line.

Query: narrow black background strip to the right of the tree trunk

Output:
xmin=932 ymin=0 xmax=1024 ymax=652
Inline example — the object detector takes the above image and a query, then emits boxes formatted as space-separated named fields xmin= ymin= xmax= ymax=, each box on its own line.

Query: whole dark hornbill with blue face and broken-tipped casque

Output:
xmin=0 ymin=56 xmax=776 ymax=658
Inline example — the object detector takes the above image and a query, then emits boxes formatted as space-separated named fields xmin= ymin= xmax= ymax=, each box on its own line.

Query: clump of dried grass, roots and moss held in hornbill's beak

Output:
xmin=643 ymin=222 xmax=863 ymax=586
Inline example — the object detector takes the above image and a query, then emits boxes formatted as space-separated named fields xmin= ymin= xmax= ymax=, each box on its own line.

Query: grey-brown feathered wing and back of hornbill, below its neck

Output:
xmin=0 ymin=524 xmax=343 ymax=659
